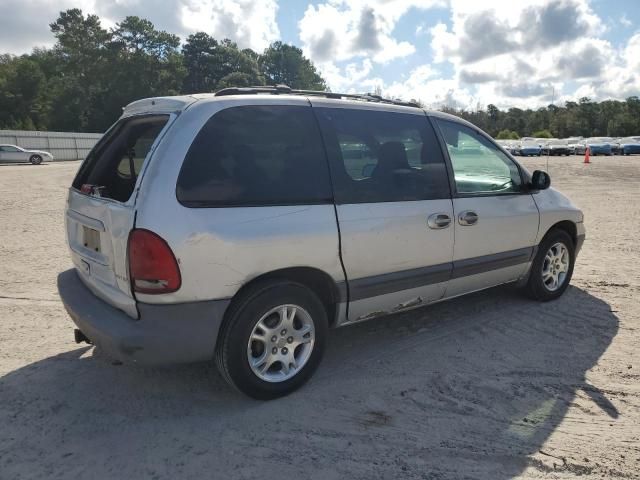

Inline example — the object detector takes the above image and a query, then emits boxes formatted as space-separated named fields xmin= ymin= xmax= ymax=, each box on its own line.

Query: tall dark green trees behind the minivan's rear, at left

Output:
xmin=0 ymin=9 xmax=327 ymax=132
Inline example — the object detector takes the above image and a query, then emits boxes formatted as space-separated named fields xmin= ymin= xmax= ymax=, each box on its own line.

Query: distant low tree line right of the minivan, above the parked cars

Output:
xmin=442 ymin=96 xmax=640 ymax=139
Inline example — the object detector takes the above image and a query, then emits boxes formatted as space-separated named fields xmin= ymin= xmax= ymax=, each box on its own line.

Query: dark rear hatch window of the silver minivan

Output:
xmin=73 ymin=115 xmax=169 ymax=202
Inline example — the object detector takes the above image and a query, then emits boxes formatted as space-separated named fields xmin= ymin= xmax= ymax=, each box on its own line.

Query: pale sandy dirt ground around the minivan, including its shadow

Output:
xmin=0 ymin=157 xmax=640 ymax=480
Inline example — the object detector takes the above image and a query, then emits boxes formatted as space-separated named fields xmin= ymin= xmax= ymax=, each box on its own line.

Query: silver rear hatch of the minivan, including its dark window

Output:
xmin=66 ymin=99 xmax=193 ymax=318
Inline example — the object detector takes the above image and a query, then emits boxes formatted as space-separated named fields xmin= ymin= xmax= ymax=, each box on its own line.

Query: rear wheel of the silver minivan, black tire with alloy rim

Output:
xmin=216 ymin=281 xmax=328 ymax=400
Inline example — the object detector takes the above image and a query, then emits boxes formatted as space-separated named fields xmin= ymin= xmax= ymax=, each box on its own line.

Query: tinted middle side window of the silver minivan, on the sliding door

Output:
xmin=315 ymin=108 xmax=449 ymax=204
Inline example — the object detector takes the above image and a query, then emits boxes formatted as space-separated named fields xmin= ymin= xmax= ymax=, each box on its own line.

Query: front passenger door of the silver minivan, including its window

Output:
xmin=436 ymin=118 xmax=539 ymax=297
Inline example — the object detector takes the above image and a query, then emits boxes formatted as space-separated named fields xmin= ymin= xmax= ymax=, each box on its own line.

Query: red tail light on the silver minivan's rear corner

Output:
xmin=128 ymin=229 xmax=182 ymax=294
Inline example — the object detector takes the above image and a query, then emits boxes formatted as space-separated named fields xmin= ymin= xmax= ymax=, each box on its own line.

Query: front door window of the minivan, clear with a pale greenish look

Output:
xmin=437 ymin=119 xmax=522 ymax=194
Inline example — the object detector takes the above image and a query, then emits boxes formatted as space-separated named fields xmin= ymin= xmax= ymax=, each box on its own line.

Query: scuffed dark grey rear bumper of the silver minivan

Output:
xmin=58 ymin=269 xmax=230 ymax=366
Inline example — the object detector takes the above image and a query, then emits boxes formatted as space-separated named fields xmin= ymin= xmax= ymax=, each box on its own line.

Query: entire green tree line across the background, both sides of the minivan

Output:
xmin=0 ymin=9 xmax=640 ymax=138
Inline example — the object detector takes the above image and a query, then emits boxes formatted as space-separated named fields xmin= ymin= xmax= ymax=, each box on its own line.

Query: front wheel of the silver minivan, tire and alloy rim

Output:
xmin=524 ymin=229 xmax=575 ymax=302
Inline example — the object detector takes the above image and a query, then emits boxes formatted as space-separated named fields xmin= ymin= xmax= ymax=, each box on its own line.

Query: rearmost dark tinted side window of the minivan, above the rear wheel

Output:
xmin=176 ymin=105 xmax=332 ymax=207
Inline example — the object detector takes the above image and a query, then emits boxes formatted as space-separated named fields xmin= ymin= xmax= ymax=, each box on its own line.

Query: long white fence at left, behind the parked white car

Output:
xmin=0 ymin=130 xmax=102 ymax=160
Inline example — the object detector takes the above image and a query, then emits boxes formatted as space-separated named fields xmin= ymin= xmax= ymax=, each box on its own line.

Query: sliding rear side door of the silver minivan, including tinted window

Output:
xmin=312 ymin=100 xmax=454 ymax=322
